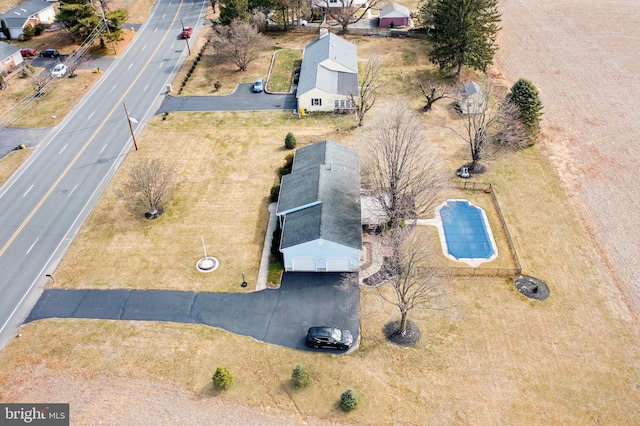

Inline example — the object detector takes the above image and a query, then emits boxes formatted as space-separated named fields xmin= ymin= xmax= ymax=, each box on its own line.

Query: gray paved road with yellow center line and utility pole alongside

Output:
xmin=0 ymin=0 xmax=207 ymax=348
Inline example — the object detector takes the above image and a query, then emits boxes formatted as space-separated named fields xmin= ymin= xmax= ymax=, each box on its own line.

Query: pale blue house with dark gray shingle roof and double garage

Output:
xmin=276 ymin=140 xmax=362 ymax=272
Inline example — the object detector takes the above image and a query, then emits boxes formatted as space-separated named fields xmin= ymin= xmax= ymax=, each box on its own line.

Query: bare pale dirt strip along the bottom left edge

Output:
xmin=3 ymin=370 xmax=348 ymax=426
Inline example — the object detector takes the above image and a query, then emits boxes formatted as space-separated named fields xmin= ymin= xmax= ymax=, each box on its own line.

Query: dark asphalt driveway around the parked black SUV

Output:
xmin=26 ymin=272 xmax=360 ymax=351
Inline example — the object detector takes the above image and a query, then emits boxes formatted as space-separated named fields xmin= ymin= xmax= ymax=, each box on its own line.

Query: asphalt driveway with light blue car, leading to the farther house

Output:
xmin=156 ymin=83 xmax=297 ymax=114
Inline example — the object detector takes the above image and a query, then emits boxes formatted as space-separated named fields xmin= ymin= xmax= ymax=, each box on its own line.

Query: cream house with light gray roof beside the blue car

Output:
xmin=296 ymin=30 xmax=358 ymax=114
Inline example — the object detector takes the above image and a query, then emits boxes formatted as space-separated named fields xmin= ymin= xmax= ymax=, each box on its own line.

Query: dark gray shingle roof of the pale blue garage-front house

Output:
xmin=276 ymin=140 xmax=362 ymax=250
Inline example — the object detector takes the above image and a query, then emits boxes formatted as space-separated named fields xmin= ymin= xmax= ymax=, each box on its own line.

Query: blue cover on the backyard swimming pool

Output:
xmin=440 ymin=200 xmax=494 ymax=259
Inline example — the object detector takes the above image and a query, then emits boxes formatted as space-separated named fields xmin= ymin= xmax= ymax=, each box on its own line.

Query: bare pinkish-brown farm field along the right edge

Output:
xmin=496 ymin=0 xmax=640 ymax=323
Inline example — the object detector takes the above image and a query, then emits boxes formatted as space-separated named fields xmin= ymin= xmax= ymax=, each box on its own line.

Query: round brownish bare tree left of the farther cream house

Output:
xmin=212 ymin=19 xmax=269 ymax=71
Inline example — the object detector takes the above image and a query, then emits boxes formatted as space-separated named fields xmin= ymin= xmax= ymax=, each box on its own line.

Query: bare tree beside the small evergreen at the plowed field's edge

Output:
xmin=452 ymin=80 xmax=529 ymax=172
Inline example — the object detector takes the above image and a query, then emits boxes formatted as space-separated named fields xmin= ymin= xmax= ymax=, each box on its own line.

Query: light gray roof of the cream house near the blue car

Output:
xmin=296 ymin=33 xmax=358 ymax=97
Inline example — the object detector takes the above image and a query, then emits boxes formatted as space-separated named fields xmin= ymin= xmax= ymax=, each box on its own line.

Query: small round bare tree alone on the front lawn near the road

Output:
xmin=116 ymin=158 xmax=175 ymax=219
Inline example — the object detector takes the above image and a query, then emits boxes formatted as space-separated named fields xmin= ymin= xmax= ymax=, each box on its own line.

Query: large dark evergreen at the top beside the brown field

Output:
xmin=420 ymin=0 xmax=501 ymax=74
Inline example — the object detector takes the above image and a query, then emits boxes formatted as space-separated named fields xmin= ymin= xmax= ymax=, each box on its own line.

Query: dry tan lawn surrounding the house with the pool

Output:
xmin=0 ymin=7 xmax=640 ymax=425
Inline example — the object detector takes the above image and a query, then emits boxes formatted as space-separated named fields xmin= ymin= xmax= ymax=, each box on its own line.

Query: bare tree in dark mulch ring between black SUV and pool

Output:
xmin=373 ymin=226 xmax=448 ymax=336
